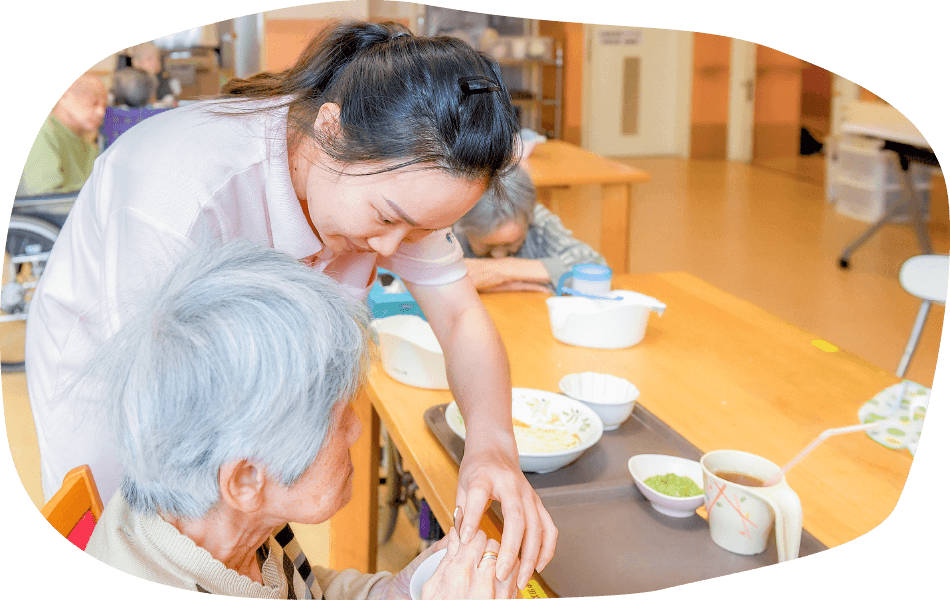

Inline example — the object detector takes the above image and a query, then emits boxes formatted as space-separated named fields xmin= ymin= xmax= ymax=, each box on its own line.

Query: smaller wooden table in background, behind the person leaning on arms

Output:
xmin=526 ymin=140 xmax=650 ymax=273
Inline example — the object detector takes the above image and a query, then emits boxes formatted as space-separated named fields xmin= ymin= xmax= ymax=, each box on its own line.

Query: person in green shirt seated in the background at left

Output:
xmin=17 ymin=73 xmax=109 ymax=196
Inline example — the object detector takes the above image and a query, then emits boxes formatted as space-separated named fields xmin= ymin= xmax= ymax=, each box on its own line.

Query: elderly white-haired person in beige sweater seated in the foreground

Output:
xmin=77 ymin=241 xmax=517 ymax=599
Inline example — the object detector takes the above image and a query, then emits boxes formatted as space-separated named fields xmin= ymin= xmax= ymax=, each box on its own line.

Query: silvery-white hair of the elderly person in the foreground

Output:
xmin=73 ymin=241 xmax=376 ymax=519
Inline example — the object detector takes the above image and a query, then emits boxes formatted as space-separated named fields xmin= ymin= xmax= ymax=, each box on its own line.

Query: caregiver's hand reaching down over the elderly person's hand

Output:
xmin=456 ymin=441 xmax=558 ymax=589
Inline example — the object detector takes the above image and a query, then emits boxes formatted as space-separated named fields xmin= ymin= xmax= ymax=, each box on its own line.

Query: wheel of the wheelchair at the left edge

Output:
xmin=0 ymin=215 xmax=60 ymax=372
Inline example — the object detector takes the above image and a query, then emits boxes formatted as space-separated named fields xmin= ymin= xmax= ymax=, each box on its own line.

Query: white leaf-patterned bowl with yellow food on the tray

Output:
xmin=445 ymin=388 xmax=604 ymax=473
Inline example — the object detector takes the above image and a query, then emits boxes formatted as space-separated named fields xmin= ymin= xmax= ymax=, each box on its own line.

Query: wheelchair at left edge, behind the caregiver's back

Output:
xmin=0 ymin=190 xmax=79 ymax=373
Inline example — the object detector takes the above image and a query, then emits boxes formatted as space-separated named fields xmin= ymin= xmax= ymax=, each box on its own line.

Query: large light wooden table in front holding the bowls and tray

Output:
xmin=330 ymin=273 xmax=912 ymax=592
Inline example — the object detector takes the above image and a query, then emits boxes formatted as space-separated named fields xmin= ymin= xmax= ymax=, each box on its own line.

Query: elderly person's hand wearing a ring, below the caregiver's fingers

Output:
xmin=422 ymin=527 xmax=518 ymax=600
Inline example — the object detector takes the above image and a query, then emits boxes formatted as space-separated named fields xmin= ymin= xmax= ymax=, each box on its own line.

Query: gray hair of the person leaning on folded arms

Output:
xmin=453 ymin=166 xmax=538 ymax=238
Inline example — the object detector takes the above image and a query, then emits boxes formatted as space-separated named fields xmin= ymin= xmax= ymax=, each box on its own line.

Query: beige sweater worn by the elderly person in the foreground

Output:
xmin=86 ymin=491 xmax=392 ymax=600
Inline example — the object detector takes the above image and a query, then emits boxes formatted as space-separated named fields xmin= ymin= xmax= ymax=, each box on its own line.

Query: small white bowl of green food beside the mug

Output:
xmin=627 ymin=454 xmax=705 ymax=518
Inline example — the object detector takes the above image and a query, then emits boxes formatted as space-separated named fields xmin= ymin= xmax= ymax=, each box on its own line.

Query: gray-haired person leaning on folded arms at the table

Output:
xmin=453 ymin=167 xmax=607 ymax=292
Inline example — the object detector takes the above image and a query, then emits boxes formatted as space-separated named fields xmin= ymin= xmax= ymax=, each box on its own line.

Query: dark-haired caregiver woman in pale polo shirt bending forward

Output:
xmin=26 ymin=23 xmax=557 ymax=588
